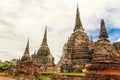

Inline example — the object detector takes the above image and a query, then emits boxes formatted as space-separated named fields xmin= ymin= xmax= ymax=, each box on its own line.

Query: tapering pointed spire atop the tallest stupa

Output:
xmin=74 ymin=4 xmax=83 ymax=31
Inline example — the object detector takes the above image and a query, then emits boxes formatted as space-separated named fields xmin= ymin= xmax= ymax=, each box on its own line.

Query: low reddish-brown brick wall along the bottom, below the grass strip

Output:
xmin=42 ymin=74 xmax=120 ymax=80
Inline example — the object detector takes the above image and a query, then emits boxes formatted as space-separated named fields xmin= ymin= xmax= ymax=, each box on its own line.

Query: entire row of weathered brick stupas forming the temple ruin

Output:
xmin=5 ymin=6 xmax=120 ymax=80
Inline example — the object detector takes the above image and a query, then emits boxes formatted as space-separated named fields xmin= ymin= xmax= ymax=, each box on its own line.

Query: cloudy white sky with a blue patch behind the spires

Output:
xmin=0 ymin=0 xmax=120 ymax=63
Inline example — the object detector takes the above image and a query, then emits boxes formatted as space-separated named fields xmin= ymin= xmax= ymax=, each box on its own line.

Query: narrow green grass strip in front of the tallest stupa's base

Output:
xmin=40 ymin=72 xmax=86 ymax=77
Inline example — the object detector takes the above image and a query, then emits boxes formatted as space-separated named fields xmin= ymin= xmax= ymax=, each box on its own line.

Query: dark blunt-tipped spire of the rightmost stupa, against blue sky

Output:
xmin=99 ymin=19 xmax=108 ymax=38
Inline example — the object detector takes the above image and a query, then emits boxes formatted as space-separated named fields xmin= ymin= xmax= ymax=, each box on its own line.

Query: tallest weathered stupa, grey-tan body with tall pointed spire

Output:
xmin=56 ymin=7 xmax=93 ymax=72
